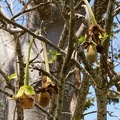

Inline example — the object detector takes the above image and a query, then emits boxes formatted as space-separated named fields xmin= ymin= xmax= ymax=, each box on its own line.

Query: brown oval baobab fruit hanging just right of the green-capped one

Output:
xmin=38 ymin=91 xmax=50 ymax=107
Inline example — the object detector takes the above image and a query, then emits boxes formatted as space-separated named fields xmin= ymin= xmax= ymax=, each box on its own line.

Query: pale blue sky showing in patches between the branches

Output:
xmin=0 ymin=0 xmax=120 ymax=120
